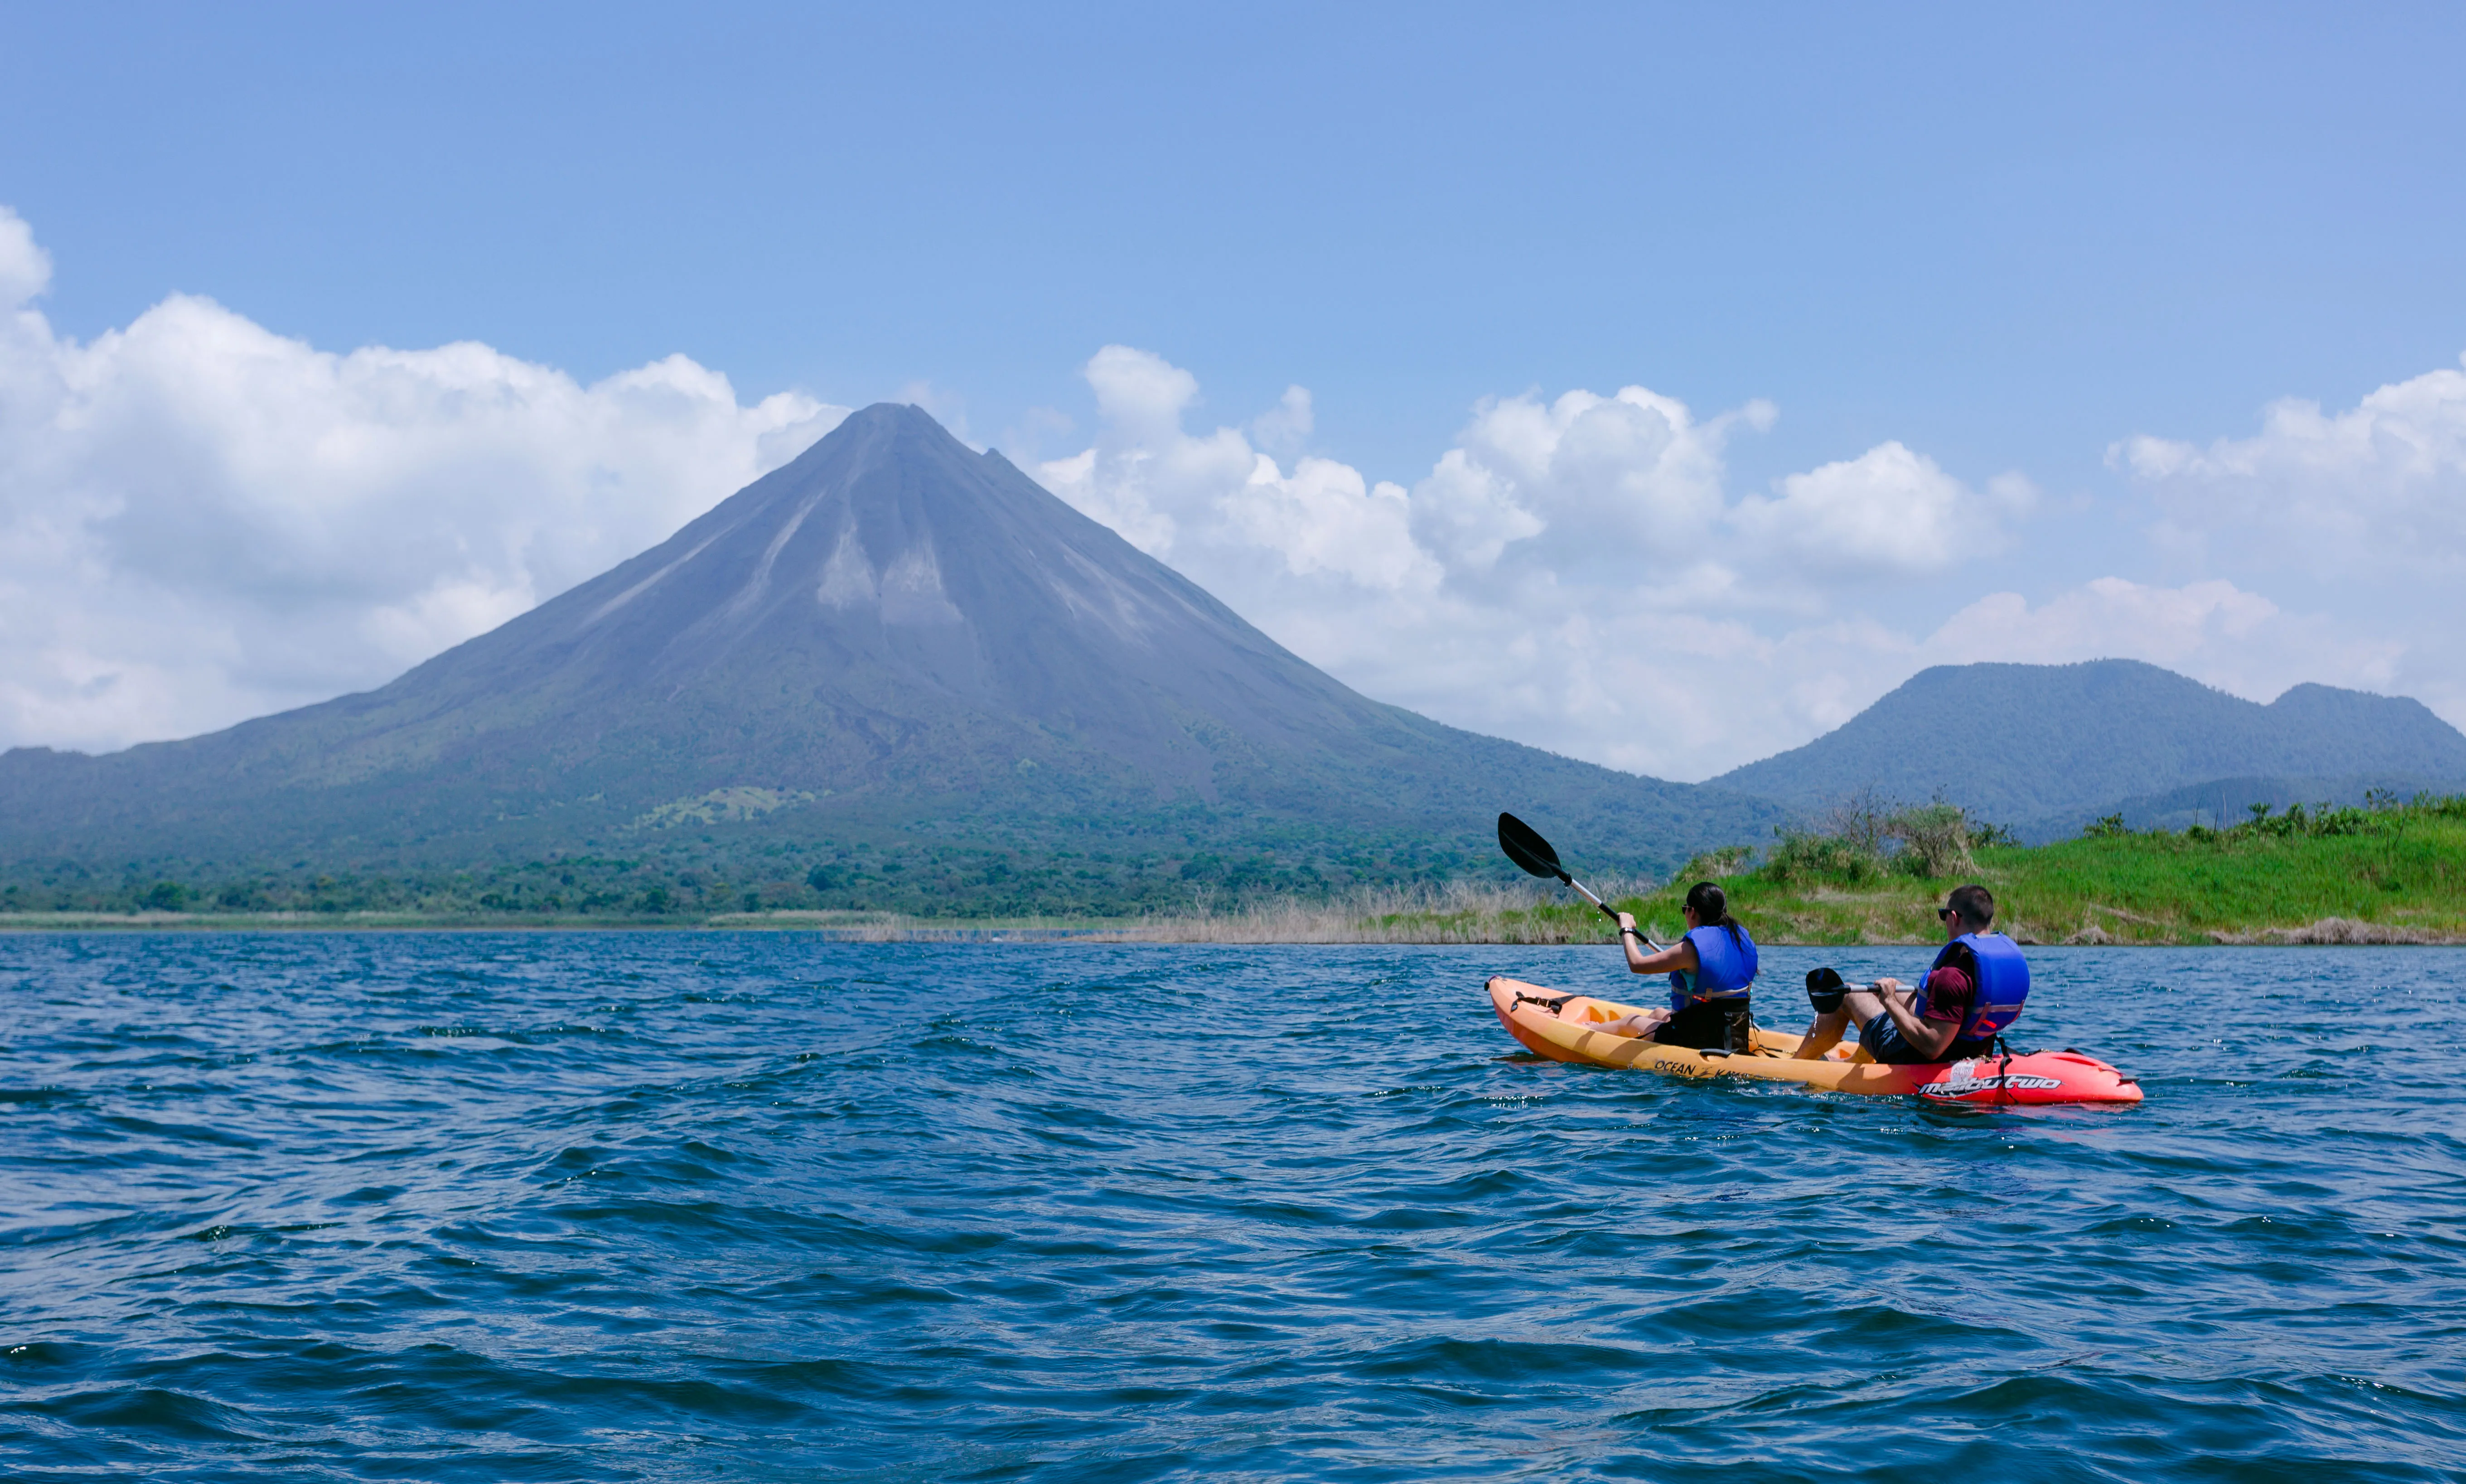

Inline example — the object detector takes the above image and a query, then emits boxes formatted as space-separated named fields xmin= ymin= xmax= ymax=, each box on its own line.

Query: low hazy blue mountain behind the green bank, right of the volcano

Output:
xmin=1712 ymin=660 xmax=2466 ymax=838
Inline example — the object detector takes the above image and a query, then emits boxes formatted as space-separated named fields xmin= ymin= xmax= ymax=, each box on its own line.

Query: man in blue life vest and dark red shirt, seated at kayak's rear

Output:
xmin=1798 ymin=885 xmax=2030 ymax=1065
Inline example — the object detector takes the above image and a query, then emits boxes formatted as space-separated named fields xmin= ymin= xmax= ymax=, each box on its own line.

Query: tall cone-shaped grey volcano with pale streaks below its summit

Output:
xmin=0 ymin=404 xmax=1780 ymax=910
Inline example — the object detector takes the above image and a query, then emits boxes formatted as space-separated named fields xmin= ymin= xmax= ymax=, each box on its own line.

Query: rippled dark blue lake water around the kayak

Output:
xmin=0 ymin=934 xmax=2466 ymax=1484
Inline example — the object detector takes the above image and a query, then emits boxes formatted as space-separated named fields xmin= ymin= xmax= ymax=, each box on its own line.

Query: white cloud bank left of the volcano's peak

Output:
xmin=0 ymin=210 xmax=846 ymax=747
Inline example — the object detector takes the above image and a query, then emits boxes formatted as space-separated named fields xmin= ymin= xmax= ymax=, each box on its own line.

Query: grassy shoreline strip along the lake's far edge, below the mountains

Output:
xmin=0 ymin=796 xmax=2466 ymax=947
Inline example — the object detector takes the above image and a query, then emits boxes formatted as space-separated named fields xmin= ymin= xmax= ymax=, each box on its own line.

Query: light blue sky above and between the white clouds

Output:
xmin=0 ymin=5 xmax=2466 ymax=774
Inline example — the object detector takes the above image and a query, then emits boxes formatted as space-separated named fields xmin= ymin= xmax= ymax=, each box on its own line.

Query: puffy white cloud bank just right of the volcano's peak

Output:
xmin=1036 ymin=345 xmax=2061 ymax=776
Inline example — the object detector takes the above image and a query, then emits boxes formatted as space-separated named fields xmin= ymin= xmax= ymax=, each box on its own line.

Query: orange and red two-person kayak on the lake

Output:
xmin=1489 ymin=976 xmax=2141 ymax=1107
